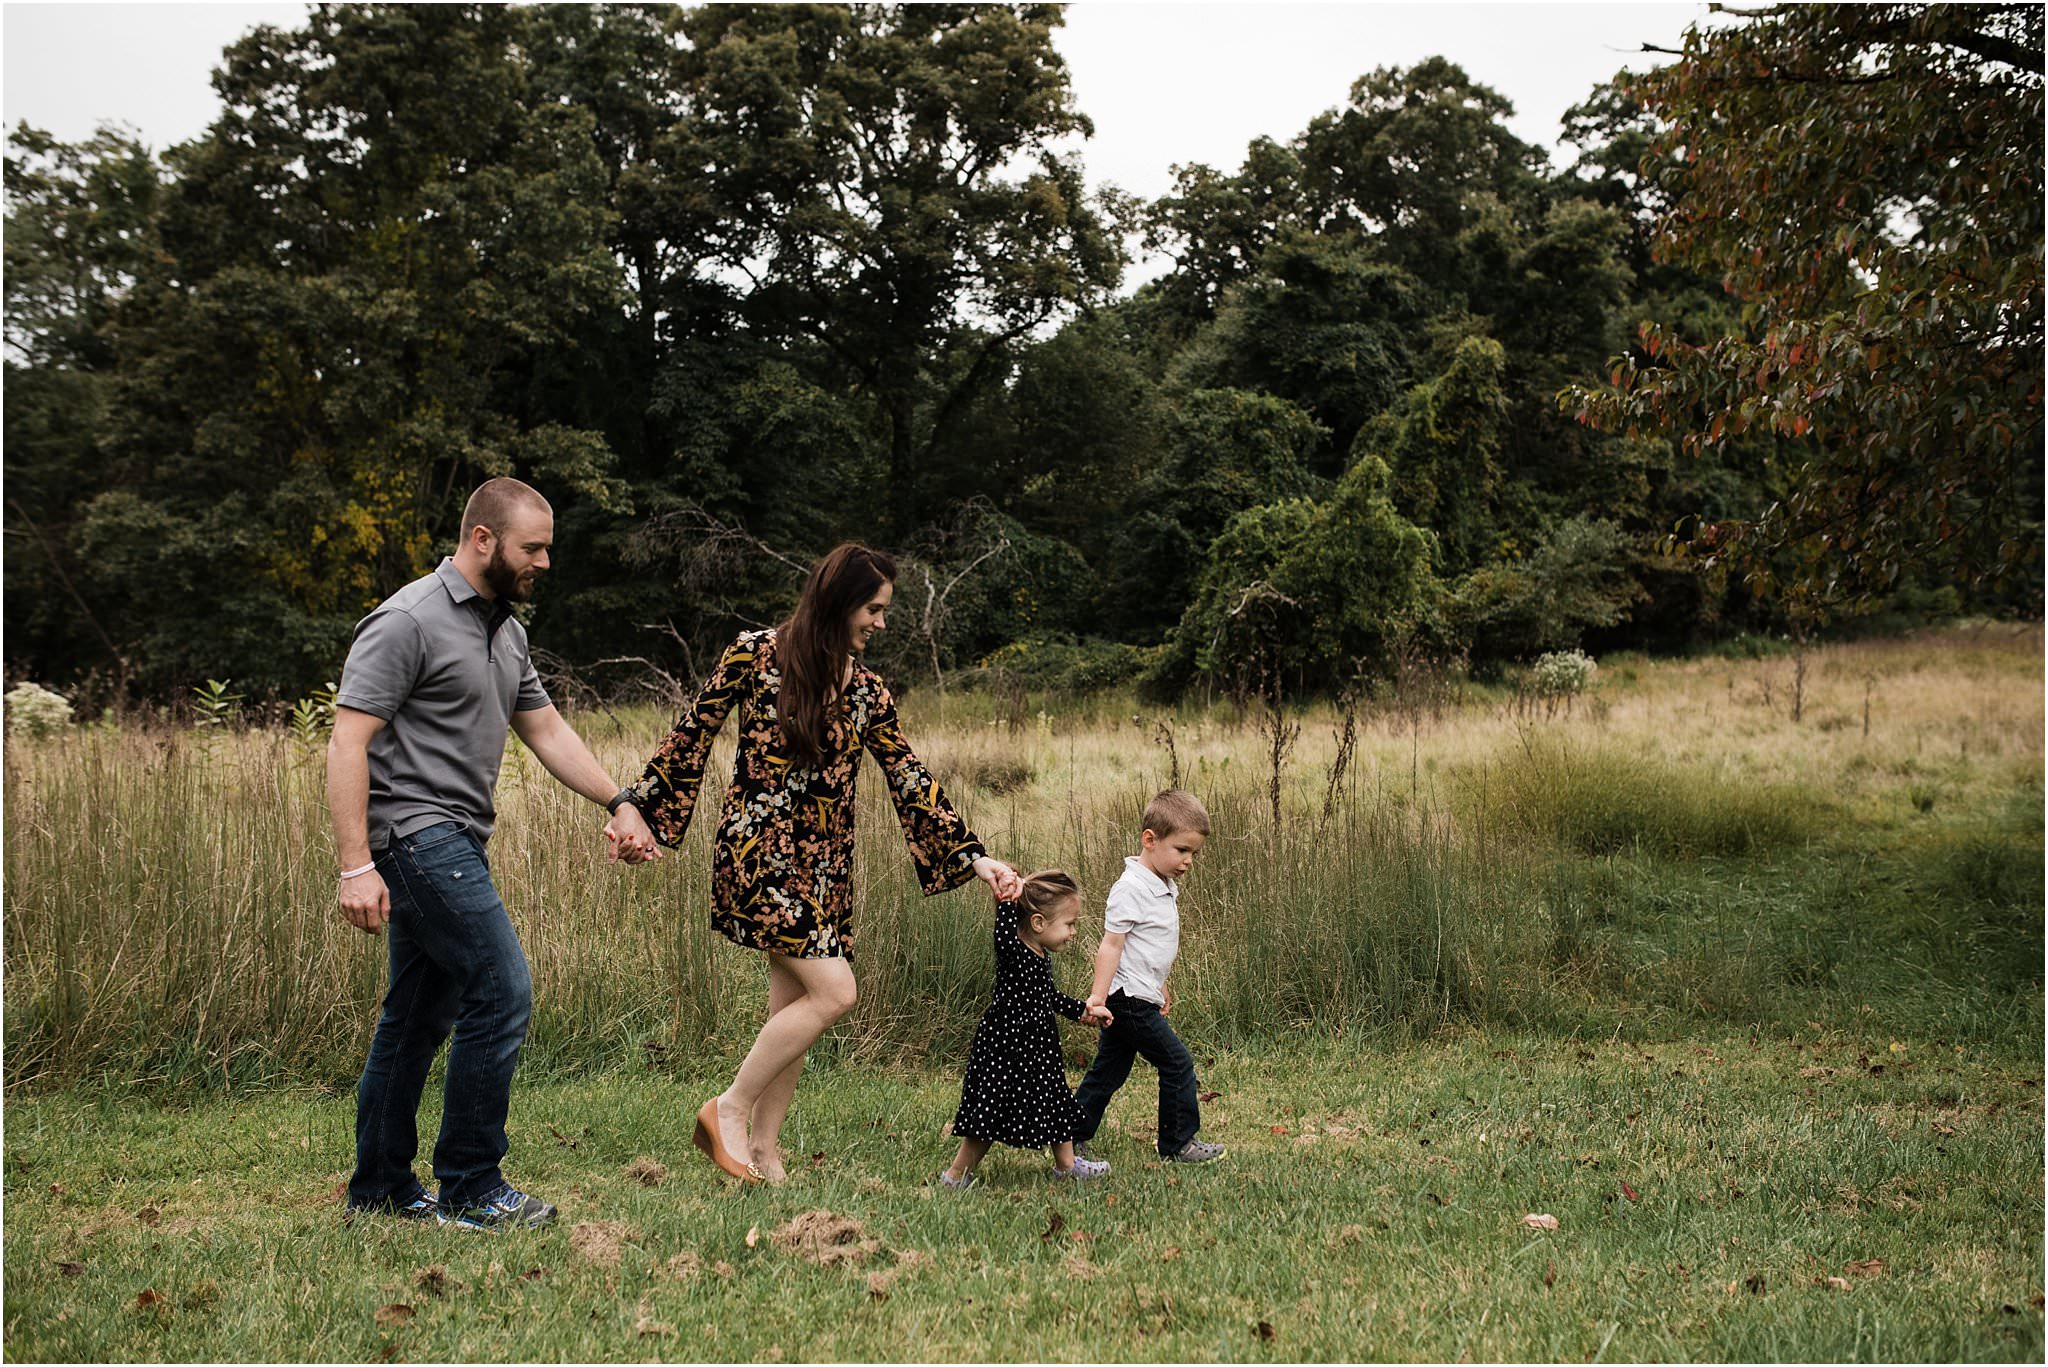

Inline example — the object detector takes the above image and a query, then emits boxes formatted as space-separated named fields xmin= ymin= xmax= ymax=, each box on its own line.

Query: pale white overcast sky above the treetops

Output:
xmin=0 ymin=0 xmax=1706 ymax=277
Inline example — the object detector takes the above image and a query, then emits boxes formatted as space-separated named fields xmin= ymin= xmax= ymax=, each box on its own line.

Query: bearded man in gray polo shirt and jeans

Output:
xmin=328 ymin=480 xmax=657 ymax=1230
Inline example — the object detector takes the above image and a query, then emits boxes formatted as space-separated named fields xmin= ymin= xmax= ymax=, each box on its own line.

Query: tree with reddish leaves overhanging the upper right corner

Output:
xmin=1563 ymin=4 xmax=2042 ymax=603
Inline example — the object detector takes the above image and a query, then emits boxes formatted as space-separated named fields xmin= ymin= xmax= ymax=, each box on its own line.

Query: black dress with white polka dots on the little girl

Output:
xmin=952 ymin=902 xmax=1087 ymax=1148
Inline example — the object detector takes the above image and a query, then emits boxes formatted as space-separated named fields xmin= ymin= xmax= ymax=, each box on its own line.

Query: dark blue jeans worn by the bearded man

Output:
xmin=348 ymin=822 xmax=532 ymax=1209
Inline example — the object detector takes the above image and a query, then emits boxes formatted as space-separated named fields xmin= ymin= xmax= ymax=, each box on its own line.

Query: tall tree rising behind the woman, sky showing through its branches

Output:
xmin=684 ymin=4 xmax=1122 ymax=535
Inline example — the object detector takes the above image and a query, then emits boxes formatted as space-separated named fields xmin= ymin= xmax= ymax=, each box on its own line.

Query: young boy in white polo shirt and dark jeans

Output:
xmin=1073 ymin=787 xmax=1223 ymax=1162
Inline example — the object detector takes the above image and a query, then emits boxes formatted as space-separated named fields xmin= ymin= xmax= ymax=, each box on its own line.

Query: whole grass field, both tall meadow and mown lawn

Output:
xmin=4 ymin=627 xmax=2048 ymax=1361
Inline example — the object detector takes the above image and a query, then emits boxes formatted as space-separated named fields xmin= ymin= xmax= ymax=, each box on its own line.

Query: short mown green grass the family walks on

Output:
xmin=6 ymin=1031 xmax=2042 ymax=1361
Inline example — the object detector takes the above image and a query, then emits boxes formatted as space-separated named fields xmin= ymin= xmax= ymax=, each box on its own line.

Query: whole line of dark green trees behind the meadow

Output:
xmin=4 ymin=4 xmax=2042 ymax=703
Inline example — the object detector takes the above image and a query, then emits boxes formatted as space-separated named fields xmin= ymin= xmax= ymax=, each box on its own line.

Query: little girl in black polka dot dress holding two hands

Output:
xmin=938 ymin=869 xmax=1112 ymax=1189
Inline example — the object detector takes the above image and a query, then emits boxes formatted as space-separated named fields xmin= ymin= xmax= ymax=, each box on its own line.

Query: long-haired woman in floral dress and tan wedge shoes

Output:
xmin=629 ymin=545 xmax=1022 ymax=1183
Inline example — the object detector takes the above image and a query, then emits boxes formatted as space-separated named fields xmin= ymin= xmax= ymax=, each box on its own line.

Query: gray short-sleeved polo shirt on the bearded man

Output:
xmin=334 ymin=557 xmax=549 ymax=851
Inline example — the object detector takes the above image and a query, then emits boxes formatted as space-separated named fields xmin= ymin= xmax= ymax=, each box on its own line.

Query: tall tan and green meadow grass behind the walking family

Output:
xmin=4 ymin=625 xmax=2042 ymax=1088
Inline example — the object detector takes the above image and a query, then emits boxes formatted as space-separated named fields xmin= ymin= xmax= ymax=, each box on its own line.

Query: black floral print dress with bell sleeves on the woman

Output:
xmin=631 ymin=629 xmax=987 ymax=959
